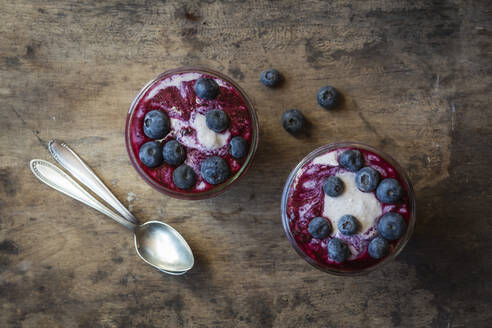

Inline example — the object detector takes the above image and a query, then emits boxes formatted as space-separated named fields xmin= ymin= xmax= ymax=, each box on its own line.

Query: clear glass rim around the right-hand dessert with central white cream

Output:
xmin=280 ymin=141 xmax=417 ymax=276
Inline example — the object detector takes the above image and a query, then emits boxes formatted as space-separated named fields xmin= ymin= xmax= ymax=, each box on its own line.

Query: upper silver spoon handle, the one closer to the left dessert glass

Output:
xmin=48 ymin=140 xmax=138 ymax=224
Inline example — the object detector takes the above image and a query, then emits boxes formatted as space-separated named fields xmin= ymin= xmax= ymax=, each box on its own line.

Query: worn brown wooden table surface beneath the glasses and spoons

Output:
xmin=0 ymin=0 xmax=492 ymax=327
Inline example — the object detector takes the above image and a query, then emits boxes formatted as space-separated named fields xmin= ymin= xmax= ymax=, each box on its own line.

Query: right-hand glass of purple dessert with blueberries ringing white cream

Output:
xmin=282 ymin=142 xmax=416 ymax=275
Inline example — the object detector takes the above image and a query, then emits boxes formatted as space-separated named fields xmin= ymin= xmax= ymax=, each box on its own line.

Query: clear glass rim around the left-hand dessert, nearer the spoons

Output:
xmin=125 ymin=66 xmax=259 ymax=200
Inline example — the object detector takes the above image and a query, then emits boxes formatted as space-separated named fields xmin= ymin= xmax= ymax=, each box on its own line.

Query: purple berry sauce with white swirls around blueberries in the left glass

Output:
xmin=128 ymin=72 xmax=254 ymax=193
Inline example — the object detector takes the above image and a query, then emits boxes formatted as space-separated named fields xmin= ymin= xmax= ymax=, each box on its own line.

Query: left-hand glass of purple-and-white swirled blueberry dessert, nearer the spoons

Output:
xmin=125 ymin=67 xmax=258 ymax=199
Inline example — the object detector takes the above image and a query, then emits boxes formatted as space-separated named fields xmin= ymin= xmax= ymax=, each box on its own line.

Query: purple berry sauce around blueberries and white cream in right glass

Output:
xmin=286 ymin=147 xmax=411 ymax=272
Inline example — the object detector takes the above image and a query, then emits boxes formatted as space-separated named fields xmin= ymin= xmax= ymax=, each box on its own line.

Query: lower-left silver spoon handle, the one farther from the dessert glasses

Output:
xmin=30 ymin=159 xmax=136 ymax=231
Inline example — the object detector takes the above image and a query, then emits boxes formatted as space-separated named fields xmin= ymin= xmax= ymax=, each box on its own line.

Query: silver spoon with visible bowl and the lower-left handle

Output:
xmin=30 ymin=159 xmax=194 ymax=275
